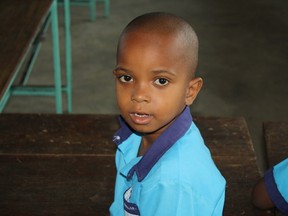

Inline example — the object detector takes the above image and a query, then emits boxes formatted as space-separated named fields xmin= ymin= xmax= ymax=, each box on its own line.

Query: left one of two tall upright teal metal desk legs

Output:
xmin=51 ymin=0 xmax=63 ymax=114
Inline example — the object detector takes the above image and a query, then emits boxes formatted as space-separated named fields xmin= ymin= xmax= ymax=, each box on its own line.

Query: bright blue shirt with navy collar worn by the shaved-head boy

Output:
xmin=110 ymin=107 xmax=226 ymax=216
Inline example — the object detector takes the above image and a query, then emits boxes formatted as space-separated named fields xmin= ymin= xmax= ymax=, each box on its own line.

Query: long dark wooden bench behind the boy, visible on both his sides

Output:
xmin=0 ymin=114 xmax=260 ymax=216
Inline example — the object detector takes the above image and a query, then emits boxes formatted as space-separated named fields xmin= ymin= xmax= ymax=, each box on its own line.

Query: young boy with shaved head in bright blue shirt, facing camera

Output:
xmin=110 ymin=13 xmax=225 ymax=216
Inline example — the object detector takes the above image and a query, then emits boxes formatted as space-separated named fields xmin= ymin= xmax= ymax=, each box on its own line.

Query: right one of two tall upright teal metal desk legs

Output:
xmin=64 ymin=0 xmax=72 ymax=113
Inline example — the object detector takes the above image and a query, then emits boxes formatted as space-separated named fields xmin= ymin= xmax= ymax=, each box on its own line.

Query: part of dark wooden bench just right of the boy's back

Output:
xmin=194 ymin=117 xmax=270 ymax=216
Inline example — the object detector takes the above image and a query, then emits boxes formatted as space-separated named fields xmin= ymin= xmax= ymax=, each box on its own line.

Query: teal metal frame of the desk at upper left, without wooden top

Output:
xmin=0 ymin=0 xmax=72 ymax=114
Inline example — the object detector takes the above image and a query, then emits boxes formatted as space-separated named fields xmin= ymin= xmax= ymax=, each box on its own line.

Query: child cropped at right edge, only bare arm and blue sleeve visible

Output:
xmin=252 ymin=158 xmax=288 ymax=215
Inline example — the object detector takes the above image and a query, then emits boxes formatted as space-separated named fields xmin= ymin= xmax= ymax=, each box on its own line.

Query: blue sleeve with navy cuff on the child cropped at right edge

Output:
xmin=264 ymin=158 xmax=288 ymax=214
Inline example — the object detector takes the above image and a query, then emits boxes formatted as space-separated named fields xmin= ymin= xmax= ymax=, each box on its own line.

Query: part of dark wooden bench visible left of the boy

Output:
xmin=0 ymin=114 xmax=118 ymax=216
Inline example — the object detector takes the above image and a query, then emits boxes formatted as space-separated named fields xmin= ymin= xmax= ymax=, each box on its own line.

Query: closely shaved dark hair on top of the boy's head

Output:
xmin=117 ymin=12 xmax=198 ymax=78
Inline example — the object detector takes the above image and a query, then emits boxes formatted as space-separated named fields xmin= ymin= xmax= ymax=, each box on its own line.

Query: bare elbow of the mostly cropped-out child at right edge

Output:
xmin=252 ymin=178 xmax=275 ymax=210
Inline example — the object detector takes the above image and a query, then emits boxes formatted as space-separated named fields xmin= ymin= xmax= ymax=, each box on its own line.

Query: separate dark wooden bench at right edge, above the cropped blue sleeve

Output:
xmin=263 ymin=121 xmax=288 ymax=216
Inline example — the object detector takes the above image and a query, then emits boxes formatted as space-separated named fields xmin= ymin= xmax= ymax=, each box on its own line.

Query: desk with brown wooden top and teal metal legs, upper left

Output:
xmin=0 ymin=0 xmax=72 ymax=113
